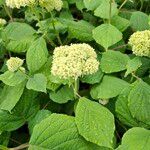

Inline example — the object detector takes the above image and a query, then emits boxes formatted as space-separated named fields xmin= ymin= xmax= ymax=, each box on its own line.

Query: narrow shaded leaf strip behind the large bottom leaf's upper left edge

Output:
xmin=28 ymin=109 xmax=51 ymax=133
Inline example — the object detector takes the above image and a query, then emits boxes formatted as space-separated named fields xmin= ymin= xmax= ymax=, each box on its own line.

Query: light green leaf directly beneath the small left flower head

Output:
xmin=0 ymin=71 xmax=26 ymax=86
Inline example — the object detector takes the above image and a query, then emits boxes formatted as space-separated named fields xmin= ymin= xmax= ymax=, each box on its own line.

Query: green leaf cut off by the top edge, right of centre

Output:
xmin=83 ymin=0 xmax=103 ymax=10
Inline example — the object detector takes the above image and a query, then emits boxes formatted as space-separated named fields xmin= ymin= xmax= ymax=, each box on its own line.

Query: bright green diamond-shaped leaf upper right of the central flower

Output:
xmin=93 ymin=24 xmax=122 ymax=49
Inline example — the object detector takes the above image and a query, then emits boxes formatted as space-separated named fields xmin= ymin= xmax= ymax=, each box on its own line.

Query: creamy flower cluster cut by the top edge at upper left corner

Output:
xmin=6 ymin=0 xmax=35 ymax=9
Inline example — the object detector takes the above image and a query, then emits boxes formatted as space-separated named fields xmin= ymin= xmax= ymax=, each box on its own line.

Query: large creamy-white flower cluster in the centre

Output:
xmin=51 ymin=43 xmax=99 ymax=80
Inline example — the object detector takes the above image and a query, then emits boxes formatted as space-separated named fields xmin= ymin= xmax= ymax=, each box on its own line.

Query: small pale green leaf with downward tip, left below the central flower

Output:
xmin=26 ymin=73 xmax=47 ymax=93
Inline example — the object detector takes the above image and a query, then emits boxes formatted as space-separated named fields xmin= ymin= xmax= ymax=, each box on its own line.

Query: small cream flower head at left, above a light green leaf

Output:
xmin=6 ymin=57 xmax=23 ymax=72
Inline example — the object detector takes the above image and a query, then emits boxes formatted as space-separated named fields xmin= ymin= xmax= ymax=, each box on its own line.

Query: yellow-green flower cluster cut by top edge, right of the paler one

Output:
xmin=39 ymin=0 xmax=63 ymax=11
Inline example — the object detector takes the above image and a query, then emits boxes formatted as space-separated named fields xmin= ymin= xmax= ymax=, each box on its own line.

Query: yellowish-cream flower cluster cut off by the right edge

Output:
xmin=129 ymin=30 xmax=150 ymax=57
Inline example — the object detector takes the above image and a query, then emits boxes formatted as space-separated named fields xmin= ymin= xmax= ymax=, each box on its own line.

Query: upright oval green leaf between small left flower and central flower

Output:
xmin=26 ymin=38 xmax=48 ymax=73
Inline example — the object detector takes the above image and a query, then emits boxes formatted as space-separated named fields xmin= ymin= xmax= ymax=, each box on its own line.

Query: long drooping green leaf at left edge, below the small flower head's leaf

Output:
xmin=0 ymin=82 xmax=25 ymax=112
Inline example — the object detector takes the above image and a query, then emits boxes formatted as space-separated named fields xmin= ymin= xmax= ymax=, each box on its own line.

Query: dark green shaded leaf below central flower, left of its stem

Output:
xmin=49 ymin=86 xmax=74 ymax=104
